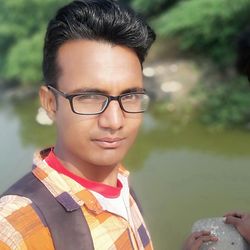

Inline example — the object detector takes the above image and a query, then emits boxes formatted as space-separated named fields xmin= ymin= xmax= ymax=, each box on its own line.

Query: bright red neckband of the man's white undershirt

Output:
xmin=45 ymin=149 xmax=122 ymax=198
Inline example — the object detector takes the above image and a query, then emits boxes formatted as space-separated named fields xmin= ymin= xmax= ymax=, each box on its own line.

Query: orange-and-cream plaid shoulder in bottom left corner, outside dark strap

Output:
xmin=0 ymin=195 xmax=51 ymax=250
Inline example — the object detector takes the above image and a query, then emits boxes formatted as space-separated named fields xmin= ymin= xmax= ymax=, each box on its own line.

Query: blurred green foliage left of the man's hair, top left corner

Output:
xmin=0 ymin=0 xmax=69 ymax=85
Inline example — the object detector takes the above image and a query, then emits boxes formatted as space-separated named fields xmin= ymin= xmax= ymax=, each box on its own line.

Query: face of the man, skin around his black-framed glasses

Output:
xmin=50 ymin=40 xmax=143 ymax=166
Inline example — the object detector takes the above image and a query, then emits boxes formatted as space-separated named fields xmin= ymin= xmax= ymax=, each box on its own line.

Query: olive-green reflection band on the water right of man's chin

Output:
xmin=127 ymin=112 xmax=250 ymax=171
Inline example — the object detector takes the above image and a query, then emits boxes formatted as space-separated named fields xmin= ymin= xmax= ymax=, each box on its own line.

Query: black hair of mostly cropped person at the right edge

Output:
xmin=236 ymin=27 xmax=250 ymax=81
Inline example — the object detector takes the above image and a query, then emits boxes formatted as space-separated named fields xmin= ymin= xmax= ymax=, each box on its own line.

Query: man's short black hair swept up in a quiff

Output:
xmin=43 ymin=0 xmax=156 ymax=86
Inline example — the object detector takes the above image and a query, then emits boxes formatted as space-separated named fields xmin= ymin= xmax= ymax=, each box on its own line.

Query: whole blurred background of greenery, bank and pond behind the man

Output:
xmin=0 ymin=0 xmax=250 ymax=250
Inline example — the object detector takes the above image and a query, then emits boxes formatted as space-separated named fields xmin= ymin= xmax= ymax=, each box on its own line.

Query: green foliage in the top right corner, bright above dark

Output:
xmin=153 ymin=0 xmax=250 ymax=65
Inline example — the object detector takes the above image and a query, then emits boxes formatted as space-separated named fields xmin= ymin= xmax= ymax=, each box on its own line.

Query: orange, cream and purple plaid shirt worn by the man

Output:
xmin=0 ymin=150 xmax=153 ymax=250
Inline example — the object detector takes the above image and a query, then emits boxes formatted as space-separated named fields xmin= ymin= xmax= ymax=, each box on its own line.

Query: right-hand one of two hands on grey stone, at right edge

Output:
xmin=224 ymin=212 xmax=250 ymax=243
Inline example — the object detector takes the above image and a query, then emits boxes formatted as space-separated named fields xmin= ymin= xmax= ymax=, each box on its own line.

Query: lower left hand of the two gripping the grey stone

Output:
xmin=183 ymin=231 xmax=218 ymax=250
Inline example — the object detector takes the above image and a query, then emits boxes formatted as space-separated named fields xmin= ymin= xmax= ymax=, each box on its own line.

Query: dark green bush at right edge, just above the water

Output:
xmin=200 ymin=78 xmax=250 ymax=127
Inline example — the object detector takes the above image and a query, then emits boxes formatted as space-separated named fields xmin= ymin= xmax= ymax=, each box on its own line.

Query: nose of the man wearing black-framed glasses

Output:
xmin=98 ymin=100 xmax=124 ymax=131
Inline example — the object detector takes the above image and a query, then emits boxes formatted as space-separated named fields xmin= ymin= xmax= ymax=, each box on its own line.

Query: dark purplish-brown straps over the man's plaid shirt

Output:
xmin=1 ymin=172 xmax=142 ymax=250
